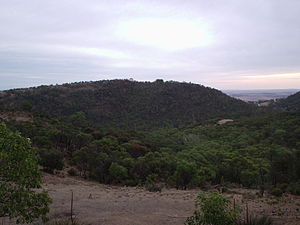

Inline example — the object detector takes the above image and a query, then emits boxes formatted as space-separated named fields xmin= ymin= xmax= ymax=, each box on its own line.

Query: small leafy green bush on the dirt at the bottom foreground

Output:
xmin=185 ymin=191 xmax=239 ymax=225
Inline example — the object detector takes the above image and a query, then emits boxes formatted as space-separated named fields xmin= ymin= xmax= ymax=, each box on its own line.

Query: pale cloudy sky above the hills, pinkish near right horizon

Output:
xmin=0 ymin=0 xmax=300 ymax=90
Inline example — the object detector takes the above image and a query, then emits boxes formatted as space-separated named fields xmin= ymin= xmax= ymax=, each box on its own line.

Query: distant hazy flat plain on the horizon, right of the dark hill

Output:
xmin=223 ymin=89 xmax=299 ymax=101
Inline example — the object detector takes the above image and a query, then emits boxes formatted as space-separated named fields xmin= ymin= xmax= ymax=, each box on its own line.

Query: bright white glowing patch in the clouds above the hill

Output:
xmin=116 ymin=18 xmax=213 ymax=51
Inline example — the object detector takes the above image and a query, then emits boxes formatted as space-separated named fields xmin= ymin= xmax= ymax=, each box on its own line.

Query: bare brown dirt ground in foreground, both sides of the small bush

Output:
xmin=37 ymin=174 xmax=300 ymax=225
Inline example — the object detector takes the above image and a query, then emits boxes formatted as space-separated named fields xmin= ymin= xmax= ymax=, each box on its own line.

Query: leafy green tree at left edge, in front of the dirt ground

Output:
xmin=0 ymin=123 xmax=51 ymax=223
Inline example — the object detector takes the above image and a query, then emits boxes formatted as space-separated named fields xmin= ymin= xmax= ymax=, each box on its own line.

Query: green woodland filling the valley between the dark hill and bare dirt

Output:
xmin=1 ymin=108 xmax=300 ymax=193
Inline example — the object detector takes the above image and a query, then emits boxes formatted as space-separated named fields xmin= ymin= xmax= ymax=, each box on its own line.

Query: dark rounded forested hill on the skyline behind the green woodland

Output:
xmin=0 ymin=80 xmax=256 ymax=129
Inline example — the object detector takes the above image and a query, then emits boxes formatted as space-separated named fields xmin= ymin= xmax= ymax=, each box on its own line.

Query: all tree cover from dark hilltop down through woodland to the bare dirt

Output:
xmin=0 ymin=80 xmax=300 ymax=194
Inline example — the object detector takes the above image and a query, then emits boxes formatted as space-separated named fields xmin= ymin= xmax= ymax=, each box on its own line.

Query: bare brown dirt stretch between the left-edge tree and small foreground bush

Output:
xmin=44 ymin=175 xmax=198 ymax=225
